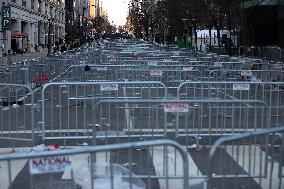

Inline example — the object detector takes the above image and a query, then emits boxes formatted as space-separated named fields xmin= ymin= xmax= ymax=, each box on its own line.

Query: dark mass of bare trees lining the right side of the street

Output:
xmin=130 ymin=0 xmax=241 ymax=51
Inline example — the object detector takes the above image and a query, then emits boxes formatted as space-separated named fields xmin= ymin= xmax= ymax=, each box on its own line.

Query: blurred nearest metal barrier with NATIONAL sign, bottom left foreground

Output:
xmin=0 ymin=140 xmax=189 ymax=189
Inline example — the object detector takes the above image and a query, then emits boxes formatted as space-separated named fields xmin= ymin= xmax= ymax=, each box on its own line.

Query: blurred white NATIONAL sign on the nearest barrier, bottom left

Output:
xmin=29 ymin=156 xmax=72 ymax=175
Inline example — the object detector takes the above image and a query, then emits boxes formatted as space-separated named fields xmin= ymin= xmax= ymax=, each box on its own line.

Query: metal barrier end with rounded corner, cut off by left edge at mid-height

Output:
xmin=0 ymin=83 xmax=35 ymax=145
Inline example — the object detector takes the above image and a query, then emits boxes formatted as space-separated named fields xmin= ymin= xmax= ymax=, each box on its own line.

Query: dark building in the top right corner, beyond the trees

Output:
xmin=243 ymin=0 xmax=284 ymax=47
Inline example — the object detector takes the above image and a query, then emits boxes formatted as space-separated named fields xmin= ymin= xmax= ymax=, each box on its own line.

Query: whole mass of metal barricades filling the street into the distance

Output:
xmin=0 ymin=40 xmax=284 ymax=189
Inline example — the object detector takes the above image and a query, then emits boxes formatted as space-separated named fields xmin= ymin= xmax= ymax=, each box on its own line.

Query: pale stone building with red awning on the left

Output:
xmin=0 ymin=0 xmax=65 ymax=55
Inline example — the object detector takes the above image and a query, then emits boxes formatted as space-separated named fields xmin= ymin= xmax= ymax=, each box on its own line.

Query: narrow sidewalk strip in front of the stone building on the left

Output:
xmin=0 ymin=48 xmax=48 ymax=66
